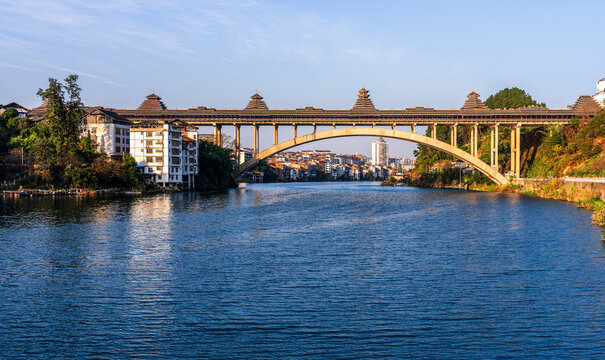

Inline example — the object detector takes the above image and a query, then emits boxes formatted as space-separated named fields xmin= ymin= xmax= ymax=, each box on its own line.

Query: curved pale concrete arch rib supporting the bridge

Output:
xmin=233 ymin=127 xmax=508 ymax=185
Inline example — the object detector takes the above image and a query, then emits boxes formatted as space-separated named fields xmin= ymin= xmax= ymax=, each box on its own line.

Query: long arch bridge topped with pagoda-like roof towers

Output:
xmin=112 ymin=88 xmax=601 ymax=184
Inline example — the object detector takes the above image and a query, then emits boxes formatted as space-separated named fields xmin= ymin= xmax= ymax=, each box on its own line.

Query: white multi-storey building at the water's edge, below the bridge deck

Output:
xmin=130 ymin=120 xmax=198 ymax=187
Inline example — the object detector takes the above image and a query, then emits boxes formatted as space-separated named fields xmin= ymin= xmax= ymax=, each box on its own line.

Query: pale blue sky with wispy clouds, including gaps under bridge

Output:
xmin=0 ymin=0 xmax=605 ymax=156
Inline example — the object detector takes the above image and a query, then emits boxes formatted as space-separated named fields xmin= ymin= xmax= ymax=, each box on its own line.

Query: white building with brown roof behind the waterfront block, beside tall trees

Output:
xmin=81 ymin=107 xmax=132 ymax=158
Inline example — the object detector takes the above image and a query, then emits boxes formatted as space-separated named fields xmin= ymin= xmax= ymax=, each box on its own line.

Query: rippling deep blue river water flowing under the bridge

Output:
xmin=0 ymin=183 xmax=605 ymax=359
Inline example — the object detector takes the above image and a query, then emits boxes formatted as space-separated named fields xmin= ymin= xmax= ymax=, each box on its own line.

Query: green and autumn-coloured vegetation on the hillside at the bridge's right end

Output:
xmin=410 ymin=88 xmax=605 ymax=187
